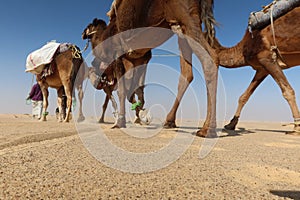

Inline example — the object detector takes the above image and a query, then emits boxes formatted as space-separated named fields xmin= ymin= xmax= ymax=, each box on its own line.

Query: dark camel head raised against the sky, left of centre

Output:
xmin=81 ymin=18 xmax=106 ymax=40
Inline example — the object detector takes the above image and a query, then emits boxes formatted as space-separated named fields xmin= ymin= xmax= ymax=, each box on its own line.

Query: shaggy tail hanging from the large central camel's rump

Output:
xmin=200 ymin=0 xmax=218 ymax=45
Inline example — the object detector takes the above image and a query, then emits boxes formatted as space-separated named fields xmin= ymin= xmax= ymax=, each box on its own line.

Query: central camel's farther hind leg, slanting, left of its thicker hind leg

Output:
xmin=164 ymin=38 xmax=193 ymax=128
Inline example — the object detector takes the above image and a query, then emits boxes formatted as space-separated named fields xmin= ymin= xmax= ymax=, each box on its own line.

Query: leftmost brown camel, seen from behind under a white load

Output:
xmin=37 ymin=45 xmax=86 ymax=122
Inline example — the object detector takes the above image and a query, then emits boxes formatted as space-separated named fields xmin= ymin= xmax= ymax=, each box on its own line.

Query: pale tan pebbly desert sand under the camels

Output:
xmin=0 ymin=114 xmax=300 ymax=199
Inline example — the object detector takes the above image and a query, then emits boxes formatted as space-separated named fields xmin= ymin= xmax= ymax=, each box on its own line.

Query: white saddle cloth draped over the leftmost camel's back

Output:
xmin=25 ymin=41 xmax=70 ymax=74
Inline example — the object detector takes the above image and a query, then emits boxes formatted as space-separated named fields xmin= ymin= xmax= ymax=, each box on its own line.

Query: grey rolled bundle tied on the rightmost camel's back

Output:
xmin=248 ymin=0 xmax=300 ymax=30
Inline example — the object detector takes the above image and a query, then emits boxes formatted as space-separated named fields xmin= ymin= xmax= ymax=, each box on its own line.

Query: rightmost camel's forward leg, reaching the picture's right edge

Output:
xmin=261 ymin=59 xmax=300 ymax=134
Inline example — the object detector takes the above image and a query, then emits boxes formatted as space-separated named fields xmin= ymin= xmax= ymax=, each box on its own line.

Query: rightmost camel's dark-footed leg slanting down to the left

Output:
xmin=224 ymin=70 xmax=268 ymax=130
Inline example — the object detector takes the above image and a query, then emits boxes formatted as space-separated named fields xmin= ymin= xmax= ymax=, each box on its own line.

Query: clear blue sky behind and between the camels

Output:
xmin=0 ymin=0 xmax=300 ymax=121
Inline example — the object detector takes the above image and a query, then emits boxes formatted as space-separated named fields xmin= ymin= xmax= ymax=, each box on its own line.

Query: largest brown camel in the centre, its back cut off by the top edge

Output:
xmin=83 ymin=0 xmax=218 ymax=136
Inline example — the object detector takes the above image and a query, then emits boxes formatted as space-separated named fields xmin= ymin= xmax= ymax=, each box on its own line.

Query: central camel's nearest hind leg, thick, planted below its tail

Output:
xmin=165 ymin=0 xmax=218 ymax=137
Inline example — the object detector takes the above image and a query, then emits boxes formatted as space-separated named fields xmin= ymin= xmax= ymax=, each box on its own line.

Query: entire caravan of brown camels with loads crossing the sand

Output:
xmin=26 ymin=0 xmax=300 ymax=137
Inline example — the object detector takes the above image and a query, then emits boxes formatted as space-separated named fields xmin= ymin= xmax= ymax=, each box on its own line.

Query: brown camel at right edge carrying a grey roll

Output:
xmin=214 ymin=7 xmax=300 ymax=132
